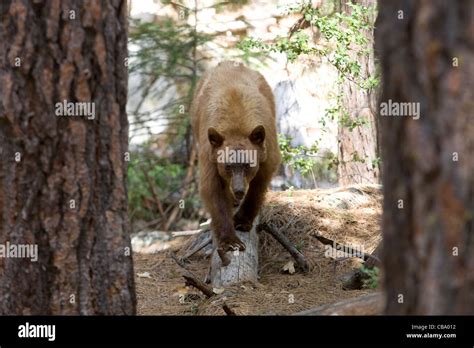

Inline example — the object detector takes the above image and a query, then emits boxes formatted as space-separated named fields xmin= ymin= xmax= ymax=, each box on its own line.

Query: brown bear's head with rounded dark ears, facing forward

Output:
xmin=208 ymin=125 xmax=266 ymax=204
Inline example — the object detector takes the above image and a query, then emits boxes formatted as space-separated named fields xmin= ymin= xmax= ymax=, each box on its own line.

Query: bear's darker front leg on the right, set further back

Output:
xmin=234 ymin=174 xmax=270 ymax=232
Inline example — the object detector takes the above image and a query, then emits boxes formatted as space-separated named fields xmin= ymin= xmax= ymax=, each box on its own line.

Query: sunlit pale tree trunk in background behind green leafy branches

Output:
xmin=338 ymin=0 xmax=379 ymax=185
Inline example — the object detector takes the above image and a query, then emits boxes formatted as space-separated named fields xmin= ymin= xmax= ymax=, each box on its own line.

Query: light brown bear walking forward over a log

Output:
xmin=191 ymin=61 xmax=281 ymax=264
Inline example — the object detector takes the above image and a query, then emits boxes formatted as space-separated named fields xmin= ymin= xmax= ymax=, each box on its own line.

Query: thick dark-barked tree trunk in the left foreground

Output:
xmin=0 ymin=0 xmax=136 ymax=315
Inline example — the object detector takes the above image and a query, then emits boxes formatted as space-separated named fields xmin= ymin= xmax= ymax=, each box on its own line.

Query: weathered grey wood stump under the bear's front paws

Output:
xmin=210 ymin=226 xmax=258 ymax=289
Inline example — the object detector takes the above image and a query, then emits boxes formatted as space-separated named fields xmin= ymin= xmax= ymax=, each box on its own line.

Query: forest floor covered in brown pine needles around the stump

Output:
xmin=134 ymin=185 xmax=382 ymax=315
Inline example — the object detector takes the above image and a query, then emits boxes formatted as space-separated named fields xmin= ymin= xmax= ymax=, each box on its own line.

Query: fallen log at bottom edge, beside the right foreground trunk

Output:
xmin=294 ymin=292 xmax=384 ymax=315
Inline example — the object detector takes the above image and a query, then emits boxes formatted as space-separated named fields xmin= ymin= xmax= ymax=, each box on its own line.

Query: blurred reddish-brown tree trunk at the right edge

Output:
xmin=376 ymin=0 xmax=474 ymax=314
